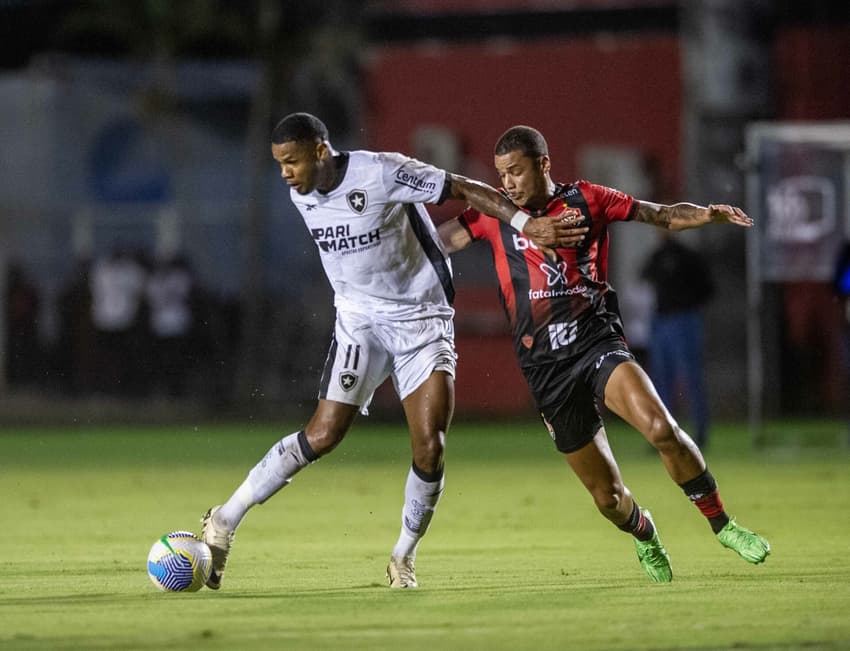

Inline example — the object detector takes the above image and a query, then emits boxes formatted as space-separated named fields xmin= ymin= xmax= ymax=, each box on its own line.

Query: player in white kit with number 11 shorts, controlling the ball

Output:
xmin=202 ymin=113 xmax=581 ymax=589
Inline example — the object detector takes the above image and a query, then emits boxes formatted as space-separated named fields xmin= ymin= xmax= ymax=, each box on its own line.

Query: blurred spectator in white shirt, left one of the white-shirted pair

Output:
xmin=89 ymin=247 xmax=147 ymax=396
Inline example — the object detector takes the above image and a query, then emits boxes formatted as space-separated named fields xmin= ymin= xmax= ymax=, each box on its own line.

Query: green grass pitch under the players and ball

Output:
xmin=0 ymin=419 xmax=850 ymax=651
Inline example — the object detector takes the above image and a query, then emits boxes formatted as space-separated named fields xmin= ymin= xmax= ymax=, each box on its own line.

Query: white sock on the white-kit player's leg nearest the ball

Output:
xmin=216 ymin=432 xmax=315 ymax=531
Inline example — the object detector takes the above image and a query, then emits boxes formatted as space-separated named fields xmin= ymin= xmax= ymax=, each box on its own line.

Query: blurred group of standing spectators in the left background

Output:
xmin=5 ymin=247 xmax=239 ymax=402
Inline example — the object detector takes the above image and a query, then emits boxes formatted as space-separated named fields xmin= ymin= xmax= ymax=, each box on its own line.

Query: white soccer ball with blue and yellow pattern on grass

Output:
xmin=148 ymin=531 xmax=212 ymax=592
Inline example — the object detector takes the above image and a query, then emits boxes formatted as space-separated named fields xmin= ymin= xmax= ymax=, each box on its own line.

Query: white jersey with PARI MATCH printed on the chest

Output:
xmin=290 ymin=151 xmax=454 ymax=320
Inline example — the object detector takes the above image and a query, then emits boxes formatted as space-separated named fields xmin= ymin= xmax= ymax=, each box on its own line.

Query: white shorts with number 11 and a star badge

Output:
xmin=319 ymin=312 xmax=457 ymax=414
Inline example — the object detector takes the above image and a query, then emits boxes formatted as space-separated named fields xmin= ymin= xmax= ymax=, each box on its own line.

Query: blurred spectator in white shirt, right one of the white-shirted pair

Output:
xmin=145 ymin=255 xmax=197 ymax=398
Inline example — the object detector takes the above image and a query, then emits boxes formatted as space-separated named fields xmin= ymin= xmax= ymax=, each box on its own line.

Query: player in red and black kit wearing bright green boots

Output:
xmin=438 ymin=126 xmax=770 ymax=583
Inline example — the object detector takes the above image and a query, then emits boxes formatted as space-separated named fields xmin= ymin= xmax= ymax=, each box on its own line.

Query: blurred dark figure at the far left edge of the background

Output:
xmin=5 ymin=264 xmax=41 ymax=386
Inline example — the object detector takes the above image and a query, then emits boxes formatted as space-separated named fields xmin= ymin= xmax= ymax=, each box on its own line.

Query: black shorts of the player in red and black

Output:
xmin=522 ymin=333 xmax=635 ymax=453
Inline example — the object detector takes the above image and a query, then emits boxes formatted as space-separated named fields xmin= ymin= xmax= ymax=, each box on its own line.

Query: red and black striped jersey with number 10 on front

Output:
xmin=460 ymin=180 xmax=638 ymax=367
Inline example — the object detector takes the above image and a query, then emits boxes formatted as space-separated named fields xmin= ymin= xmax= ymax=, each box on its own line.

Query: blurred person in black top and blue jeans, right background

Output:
xmin=642 ymin=231 xmax=714 ymax=448
